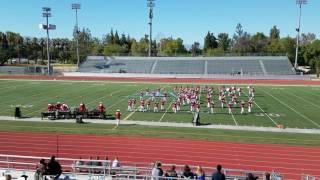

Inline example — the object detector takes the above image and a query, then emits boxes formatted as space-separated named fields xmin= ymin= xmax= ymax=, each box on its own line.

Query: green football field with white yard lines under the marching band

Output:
xmin=0 ymin=80 xmax=320 ymax=129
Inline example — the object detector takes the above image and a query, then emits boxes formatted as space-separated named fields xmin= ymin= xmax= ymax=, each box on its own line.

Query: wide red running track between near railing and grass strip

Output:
xmin=0 ymin=132 xmax=320 ymax=179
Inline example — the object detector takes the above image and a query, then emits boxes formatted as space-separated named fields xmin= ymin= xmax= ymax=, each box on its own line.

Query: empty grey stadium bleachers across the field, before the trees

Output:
xmin=79 ymin=56 xmax=296 ymax=75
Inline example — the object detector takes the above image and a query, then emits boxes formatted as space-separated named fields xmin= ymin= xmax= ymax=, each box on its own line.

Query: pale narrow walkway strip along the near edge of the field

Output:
xmin=0 ymin=116 xmax=320 ymax=134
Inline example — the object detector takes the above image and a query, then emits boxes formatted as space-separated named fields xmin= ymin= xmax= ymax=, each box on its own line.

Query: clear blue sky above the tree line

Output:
xmin=0 ymin=0 xmax=320 ymax=44
